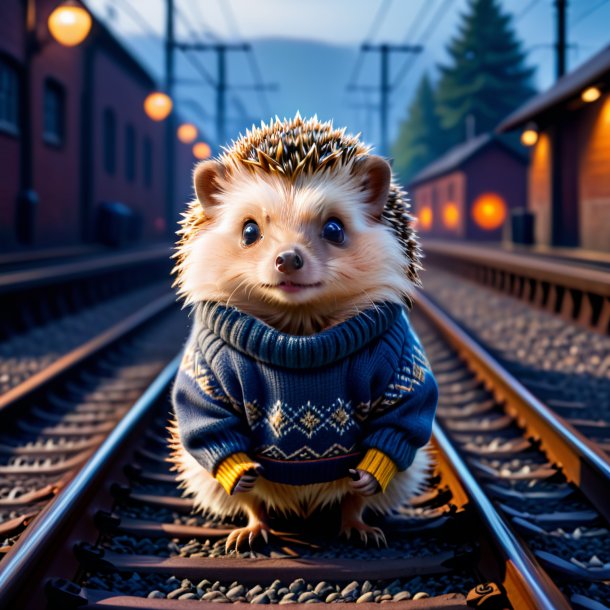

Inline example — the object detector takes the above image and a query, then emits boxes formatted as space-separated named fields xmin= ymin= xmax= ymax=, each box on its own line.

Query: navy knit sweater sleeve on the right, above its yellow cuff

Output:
xmin=362 ymin=318 xmax=438 ymax=470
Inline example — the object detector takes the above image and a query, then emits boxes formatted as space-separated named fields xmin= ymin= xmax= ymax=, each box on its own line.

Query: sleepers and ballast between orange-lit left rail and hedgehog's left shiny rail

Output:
xmin=0 ymin=298 xmax=185 ymax=566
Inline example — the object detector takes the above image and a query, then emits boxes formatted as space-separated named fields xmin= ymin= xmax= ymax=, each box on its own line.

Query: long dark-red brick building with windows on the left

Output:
xmin=0 ymin=0 xmax=194 ymax=251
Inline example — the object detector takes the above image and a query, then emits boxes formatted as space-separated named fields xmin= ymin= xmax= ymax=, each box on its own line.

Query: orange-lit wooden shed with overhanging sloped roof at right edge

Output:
xmin=499 ymin=45 xmax=610 ymax=252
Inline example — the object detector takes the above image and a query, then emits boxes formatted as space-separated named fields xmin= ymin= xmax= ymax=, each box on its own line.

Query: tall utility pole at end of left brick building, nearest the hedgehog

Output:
xmin=164 ymin=0 xmax=176 ymax=236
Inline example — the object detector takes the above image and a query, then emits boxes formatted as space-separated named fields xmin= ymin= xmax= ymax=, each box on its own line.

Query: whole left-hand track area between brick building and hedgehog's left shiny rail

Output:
xmin=0 ymin=248 xmax=190 ymax=584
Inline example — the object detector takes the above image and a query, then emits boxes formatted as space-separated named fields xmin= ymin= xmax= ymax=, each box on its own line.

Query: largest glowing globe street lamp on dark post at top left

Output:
xmin=16 ymin=0 xmax=92 ymax=244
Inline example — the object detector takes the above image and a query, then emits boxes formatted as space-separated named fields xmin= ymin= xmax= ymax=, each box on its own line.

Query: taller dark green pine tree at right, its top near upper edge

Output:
xmin=436 ymin=0 xmax=534 ymax=144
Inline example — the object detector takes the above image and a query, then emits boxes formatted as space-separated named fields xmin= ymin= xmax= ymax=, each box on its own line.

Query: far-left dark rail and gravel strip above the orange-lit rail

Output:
xmin=0 ymin=246 xmax=170 ymax=394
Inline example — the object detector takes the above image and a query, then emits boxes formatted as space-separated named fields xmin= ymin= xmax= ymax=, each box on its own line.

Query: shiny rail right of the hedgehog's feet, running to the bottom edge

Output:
xmin=433 ymin=422 xmax=571 ymax=610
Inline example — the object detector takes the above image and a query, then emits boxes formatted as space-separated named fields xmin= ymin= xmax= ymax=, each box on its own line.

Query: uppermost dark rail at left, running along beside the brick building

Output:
xmin=0 ymin=244 xmax=171 ymax=295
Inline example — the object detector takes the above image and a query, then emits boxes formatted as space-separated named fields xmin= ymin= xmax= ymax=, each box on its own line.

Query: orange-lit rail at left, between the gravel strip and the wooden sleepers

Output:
xmin=0 ymin=292 xmax=176 ymax=413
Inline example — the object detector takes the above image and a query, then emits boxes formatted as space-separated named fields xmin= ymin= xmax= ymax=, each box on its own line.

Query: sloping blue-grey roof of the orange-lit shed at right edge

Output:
xmin=497 ymin=45 xmax=610 ymax=131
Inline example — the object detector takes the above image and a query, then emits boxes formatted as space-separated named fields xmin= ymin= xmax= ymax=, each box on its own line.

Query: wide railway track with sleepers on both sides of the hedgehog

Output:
xmin=0 ymin=245 xmax=610 ymax=610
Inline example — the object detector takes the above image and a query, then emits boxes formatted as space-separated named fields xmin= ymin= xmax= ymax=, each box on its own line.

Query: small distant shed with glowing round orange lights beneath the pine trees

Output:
xmin=409 ymin=133 xmax=527 ymax=241
